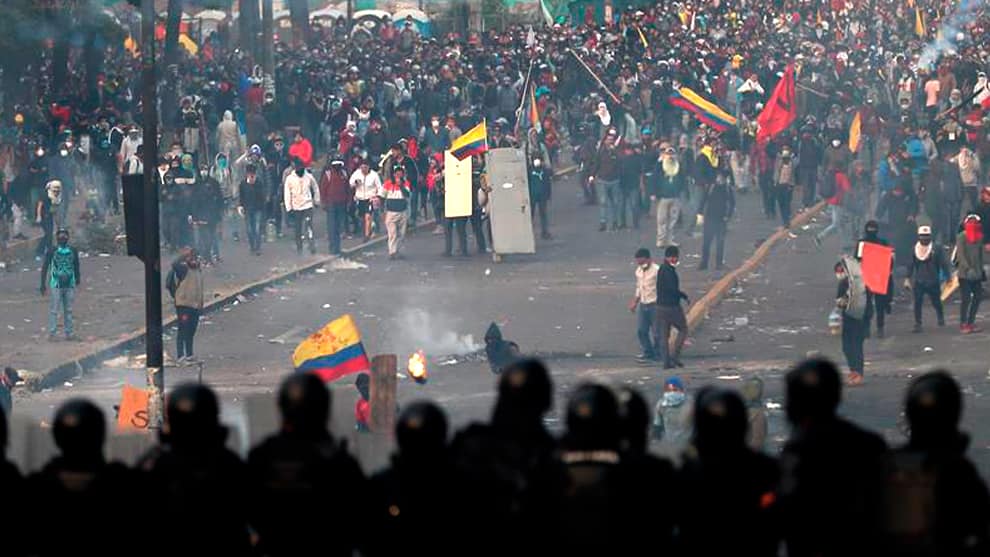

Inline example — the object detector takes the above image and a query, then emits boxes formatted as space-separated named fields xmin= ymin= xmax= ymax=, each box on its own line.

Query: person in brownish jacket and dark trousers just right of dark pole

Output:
xmin=165 ymin=248 xmax=204 ymax=365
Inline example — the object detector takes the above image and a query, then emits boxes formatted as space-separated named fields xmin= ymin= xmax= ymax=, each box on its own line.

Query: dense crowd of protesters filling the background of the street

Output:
xmin=0 ymin=1 xmax=990 ymax=266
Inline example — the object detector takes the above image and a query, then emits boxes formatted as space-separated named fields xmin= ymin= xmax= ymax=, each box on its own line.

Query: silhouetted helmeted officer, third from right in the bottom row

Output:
xmin=675 ymin=387 xmax=780 ymax=557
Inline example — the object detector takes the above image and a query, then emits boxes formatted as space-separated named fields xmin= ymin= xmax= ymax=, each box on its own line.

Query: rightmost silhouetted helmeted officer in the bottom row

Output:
xmin=881 ymin=371 xmax=990 ymax=556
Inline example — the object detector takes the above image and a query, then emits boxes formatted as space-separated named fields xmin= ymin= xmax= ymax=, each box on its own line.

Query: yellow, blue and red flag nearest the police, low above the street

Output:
xmin=292 ymin=314 xmax=371 ymax=382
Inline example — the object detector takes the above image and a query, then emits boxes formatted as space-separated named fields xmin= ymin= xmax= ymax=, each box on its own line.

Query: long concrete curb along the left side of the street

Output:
xmin=26 ymin=166 xmax=578 ymax=392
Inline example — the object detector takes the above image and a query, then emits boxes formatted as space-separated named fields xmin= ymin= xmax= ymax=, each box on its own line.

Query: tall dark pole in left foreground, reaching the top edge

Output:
xmin=141 ymin=0 xmax=165 ymax=429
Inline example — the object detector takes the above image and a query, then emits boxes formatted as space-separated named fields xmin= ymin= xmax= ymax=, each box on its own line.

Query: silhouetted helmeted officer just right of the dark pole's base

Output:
xmin=138 ymin=384 xmax=251 ymax=556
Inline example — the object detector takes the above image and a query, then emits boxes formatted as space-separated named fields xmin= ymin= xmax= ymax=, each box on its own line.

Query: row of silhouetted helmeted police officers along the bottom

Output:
xmin=0 ymin=359 xmax=990 ymax=557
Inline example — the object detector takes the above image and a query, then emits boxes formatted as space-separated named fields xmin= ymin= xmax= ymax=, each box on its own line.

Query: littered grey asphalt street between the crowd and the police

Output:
xmin=9 ymin=172 xmax=990 ymax=473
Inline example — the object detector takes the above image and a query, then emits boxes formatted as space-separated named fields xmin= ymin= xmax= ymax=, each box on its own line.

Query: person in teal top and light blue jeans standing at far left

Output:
xmin=40 ymin=228 xmax=82 ymax=340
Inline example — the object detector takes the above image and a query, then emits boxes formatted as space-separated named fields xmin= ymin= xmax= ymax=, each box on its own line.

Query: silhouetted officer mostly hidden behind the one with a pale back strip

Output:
xmin=617 ymin=387 xmax=674 ymax=555
